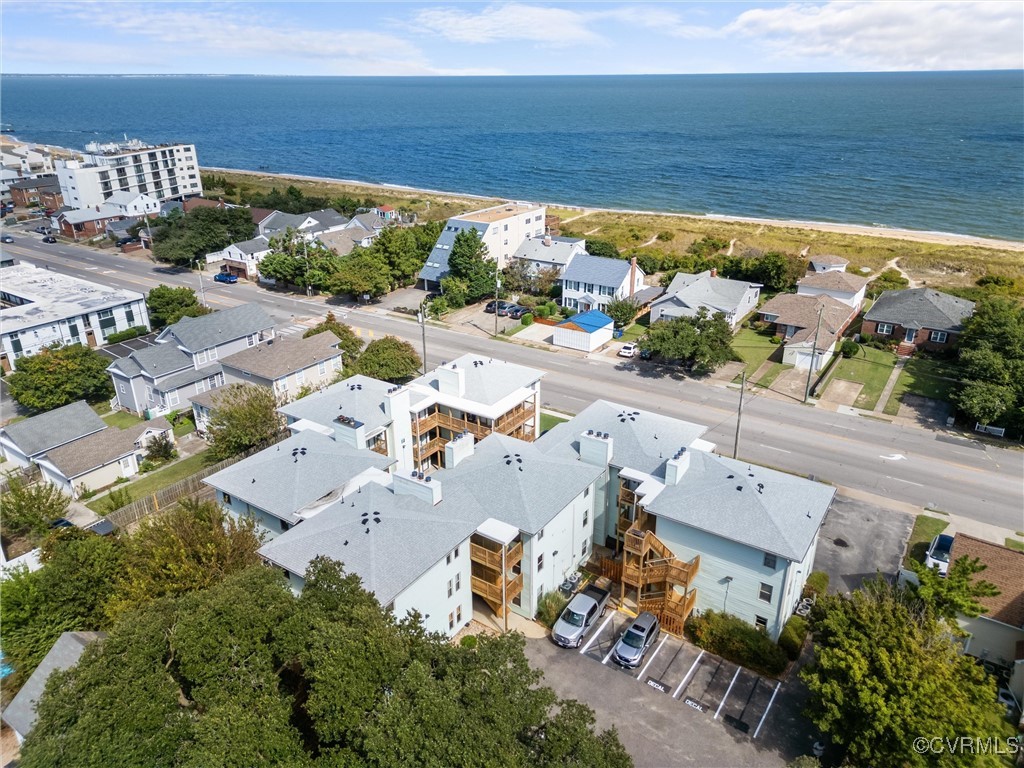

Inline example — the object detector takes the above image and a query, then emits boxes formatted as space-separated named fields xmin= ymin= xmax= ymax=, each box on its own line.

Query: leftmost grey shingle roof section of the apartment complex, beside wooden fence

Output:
xmin=204 ymin=430 xmax=395 ymax=528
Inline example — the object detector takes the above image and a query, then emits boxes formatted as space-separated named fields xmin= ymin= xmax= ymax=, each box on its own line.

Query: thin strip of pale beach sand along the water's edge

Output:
xmin=200 ymin=166 xmax=1024 ymax=253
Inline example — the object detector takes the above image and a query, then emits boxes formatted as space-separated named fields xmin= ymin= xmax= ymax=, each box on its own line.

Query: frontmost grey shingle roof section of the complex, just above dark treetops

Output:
xmin=259 ymin=482 xmax=476 ymax=604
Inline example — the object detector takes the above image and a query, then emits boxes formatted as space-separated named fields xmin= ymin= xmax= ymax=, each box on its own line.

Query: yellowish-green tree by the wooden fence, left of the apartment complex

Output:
xmin=208 ymin=384 xmax=282 ymax=461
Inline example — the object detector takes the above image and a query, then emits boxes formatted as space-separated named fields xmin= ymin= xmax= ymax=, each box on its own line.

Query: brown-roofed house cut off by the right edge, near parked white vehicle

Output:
xmin=949 ymin=534 xmax=1024 ymax=703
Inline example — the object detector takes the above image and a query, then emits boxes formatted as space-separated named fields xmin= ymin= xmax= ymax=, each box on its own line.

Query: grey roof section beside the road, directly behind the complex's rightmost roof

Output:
xmin=535 ymin=400 xmax=708 ymax=475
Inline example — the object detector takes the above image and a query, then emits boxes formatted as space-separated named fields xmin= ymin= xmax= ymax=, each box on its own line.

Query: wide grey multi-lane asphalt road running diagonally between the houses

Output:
xmin=2 ymin=229 xmax=1024 ymax=530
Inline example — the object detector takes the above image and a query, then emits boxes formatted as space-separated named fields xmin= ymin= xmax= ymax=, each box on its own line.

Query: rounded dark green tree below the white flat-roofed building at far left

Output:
xmin=7 ymin=344 xmax=114 ymax=411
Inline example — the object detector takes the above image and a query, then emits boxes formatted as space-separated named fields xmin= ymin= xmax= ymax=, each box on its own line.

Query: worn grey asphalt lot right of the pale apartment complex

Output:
xmin=814 ymin=496 xmax=913 ymax=593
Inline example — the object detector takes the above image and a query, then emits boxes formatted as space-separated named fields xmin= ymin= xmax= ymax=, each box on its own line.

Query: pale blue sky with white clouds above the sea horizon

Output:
xmin=6 ymin=0 xmax=1024 ymax=76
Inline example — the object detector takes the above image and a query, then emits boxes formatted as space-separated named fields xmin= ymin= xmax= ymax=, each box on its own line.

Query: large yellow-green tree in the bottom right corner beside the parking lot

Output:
xmin=801 ymin=579 xmax=995 ymax=768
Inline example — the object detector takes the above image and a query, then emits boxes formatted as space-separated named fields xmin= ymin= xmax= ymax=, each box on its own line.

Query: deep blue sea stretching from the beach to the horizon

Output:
xmin=0 ymin=72 xmax=1024 ymax=240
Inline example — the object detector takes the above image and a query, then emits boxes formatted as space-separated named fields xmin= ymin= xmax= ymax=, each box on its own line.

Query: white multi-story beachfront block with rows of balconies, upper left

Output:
xmin=56 ymin=139 xmax=203 ymax=208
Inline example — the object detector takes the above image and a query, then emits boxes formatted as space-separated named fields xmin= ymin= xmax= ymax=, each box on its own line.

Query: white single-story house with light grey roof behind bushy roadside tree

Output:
xmin=650 ymin=269 xmax=761 ymax=328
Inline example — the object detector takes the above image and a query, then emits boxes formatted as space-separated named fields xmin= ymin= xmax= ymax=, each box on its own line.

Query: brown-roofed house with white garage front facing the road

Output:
xmin=758 ymin=293 xmax=858 ymax=371
